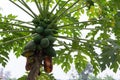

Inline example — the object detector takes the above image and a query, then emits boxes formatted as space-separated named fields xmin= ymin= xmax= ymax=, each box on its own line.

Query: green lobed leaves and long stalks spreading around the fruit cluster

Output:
xmin=0 ymin=0 xmax=120 ymax=78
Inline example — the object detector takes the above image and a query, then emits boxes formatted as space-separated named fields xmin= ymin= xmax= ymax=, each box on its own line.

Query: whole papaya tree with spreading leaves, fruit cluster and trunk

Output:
xmin=0 ymin=0 xmax=120 ymax=80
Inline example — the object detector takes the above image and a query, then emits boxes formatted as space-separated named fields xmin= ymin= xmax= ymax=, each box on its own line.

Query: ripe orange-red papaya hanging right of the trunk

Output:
xmin=44 ymin=56 xmax=53 ymax=73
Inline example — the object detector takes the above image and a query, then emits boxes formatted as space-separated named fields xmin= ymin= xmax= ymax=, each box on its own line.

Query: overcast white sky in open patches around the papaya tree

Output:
xmin=0 ymin=0 xmax=120 ymax=80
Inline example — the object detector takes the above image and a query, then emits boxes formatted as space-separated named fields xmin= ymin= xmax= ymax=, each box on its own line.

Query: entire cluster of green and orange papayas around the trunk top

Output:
xmin=22 ymin=15 xmax=58 ymax=73
